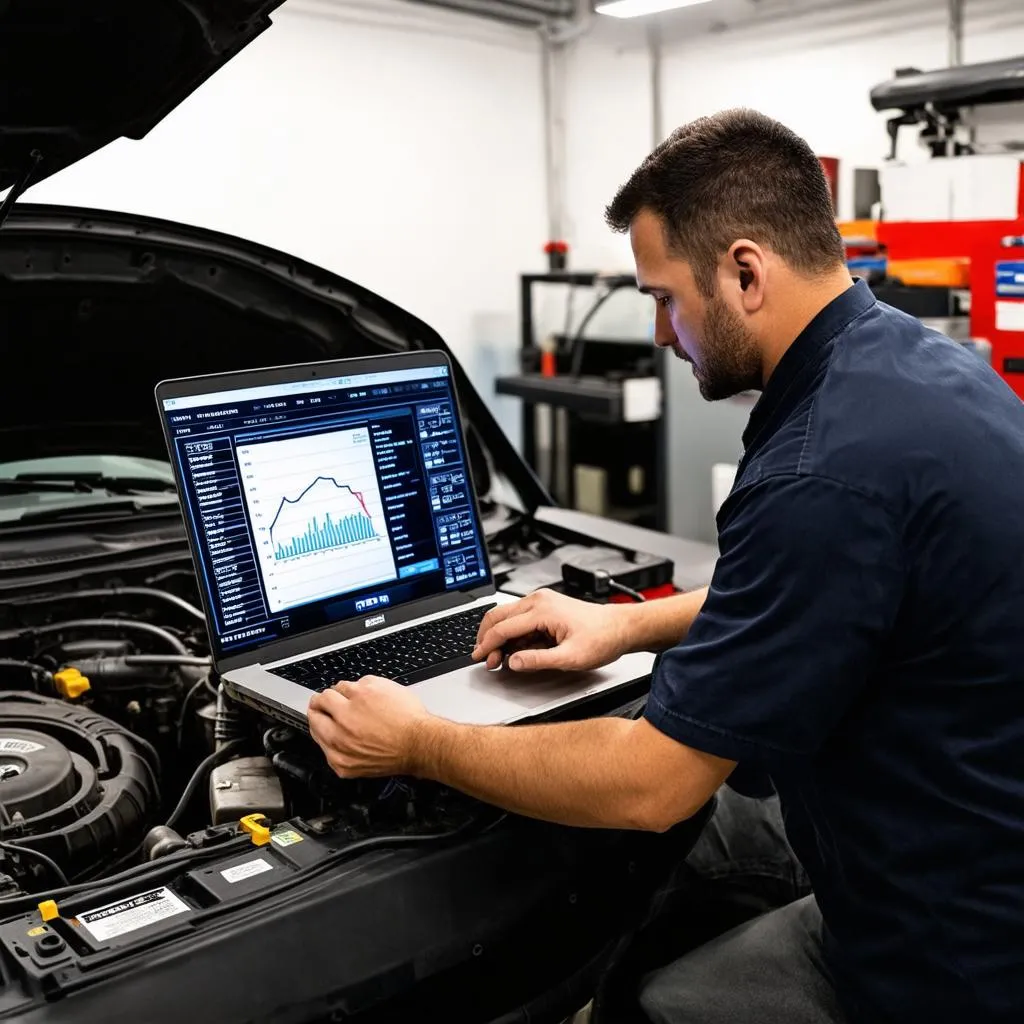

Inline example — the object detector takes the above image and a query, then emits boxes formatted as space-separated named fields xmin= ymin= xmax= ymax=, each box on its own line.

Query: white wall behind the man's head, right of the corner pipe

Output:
xmin=566 ymin=0 xmax=1024 ymax=260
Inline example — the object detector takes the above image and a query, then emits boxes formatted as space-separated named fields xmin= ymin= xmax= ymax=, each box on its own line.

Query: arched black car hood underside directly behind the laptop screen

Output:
xmin=0 ymin=204 xmax=551 ymax=512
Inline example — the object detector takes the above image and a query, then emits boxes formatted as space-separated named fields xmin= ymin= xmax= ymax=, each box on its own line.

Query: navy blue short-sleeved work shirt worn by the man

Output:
xmin=647 ymin=283 xmax=1024 ymax=1024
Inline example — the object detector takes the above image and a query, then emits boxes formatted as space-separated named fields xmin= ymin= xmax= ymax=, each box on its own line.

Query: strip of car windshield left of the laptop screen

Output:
xmin=0 ymin=455 xmax=176 ymax=526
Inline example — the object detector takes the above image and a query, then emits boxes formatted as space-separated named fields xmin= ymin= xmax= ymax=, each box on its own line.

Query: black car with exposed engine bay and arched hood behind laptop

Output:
xmin=0 ymin=207 xmax=707 ymax=1024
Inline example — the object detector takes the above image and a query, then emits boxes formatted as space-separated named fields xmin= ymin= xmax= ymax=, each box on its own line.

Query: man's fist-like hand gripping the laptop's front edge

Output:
xmin=309 ymin=676 xmax=432 ymax=778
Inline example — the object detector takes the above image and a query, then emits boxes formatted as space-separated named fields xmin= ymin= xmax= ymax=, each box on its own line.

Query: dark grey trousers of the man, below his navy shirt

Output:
xmin=640 ymin=786 xmax=844 ymax=1024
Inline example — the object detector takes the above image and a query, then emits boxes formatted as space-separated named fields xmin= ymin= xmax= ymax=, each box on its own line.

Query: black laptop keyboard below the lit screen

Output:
xmin=270 ymin=604 xmax=497 ymax=690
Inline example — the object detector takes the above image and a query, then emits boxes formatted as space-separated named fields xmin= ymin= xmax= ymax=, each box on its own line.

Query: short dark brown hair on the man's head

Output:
xmin=605 ymin=110 xmax=846 ymax=296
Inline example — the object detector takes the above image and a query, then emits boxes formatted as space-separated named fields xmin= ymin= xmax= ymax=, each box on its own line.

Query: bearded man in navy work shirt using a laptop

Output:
xmin=309 ymin=111 xmax=1024 ymax=1024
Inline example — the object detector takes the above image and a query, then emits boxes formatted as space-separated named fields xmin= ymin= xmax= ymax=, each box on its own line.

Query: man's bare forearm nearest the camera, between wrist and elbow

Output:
xmin=413 ymin=718 xmax=660 ymax=828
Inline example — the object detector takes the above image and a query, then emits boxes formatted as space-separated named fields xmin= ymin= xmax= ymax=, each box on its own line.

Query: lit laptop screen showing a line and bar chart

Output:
xmin=162 ymin=366 xmax=489 ymax=656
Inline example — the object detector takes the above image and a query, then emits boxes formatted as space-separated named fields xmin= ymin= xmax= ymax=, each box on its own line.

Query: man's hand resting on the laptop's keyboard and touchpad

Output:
xmin=473 ymin=590 xmax=632 ymax=672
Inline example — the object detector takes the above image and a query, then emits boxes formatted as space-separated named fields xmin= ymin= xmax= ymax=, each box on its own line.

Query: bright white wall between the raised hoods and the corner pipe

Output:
xmin=26 ymin=0 xmax=547 ymax=438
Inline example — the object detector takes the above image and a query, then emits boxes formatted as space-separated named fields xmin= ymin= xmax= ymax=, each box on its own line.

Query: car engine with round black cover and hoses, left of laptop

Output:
xmin=0 ymin=570 xmax=474 ymax=896
